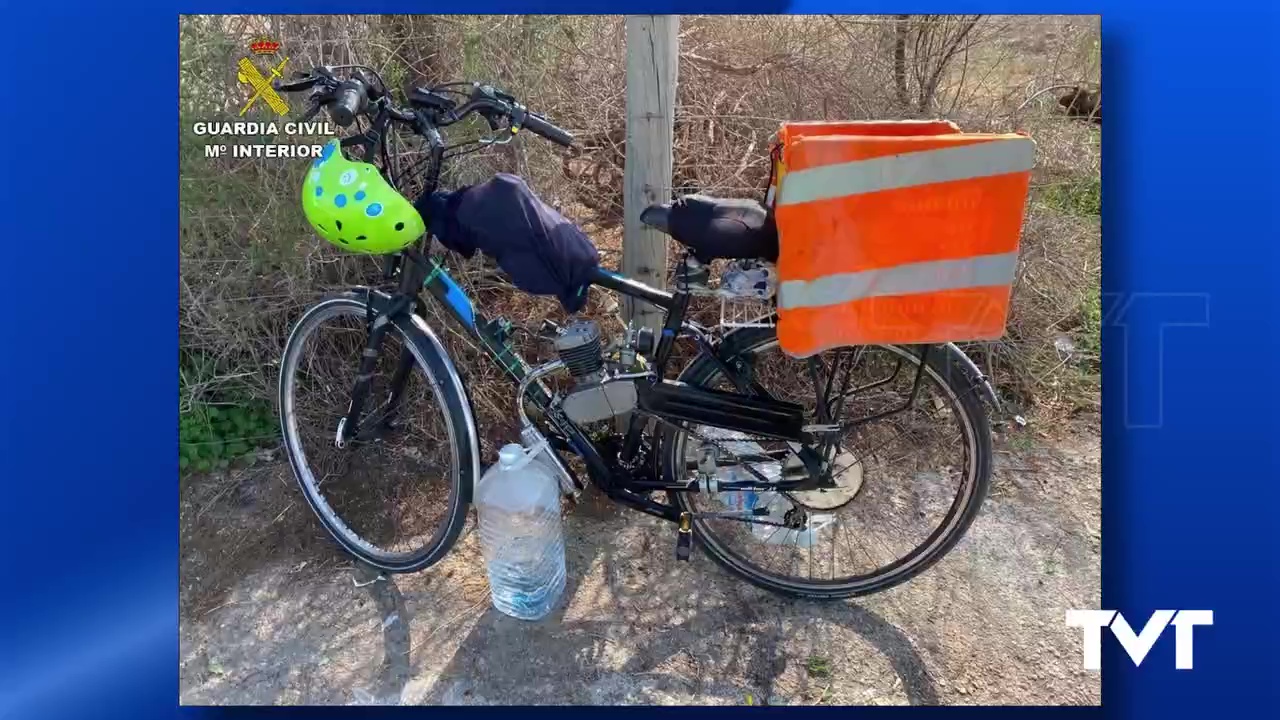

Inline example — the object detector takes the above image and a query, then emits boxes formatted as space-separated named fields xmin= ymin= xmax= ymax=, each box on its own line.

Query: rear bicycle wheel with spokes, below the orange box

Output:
xmin=662 ymin=328 xmax=992 ymax=600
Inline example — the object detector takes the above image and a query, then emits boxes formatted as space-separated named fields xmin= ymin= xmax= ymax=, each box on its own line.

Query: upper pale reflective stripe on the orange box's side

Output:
xmin=778 ymin=137 xmax=1036 ymax=206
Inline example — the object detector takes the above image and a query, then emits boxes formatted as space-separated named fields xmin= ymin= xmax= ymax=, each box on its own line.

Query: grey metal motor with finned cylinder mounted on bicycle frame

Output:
xmin=556 ymin=320 xmax=636 ymax=423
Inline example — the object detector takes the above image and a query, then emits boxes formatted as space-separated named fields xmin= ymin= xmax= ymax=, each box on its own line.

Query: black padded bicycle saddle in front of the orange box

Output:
xmin=640 ymin=195 xmax=778 ymax=263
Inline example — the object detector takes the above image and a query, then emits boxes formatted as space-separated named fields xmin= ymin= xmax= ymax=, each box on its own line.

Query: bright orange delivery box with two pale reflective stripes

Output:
xmin=767 ymin=120 xmax=1036 ymax=357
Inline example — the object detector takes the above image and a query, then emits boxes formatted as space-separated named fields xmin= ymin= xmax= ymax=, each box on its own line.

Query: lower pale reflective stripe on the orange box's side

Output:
xmin=778 ymin=252 xmax=1018 ymax=310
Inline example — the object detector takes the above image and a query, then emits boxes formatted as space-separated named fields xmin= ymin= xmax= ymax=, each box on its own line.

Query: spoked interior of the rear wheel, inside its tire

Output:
xmin=675 ymin=341 xmax=989 ymax=594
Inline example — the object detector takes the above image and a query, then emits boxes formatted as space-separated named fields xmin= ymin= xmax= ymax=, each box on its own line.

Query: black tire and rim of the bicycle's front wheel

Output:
xmin=279 ymin=291 xmax=480 ymax=573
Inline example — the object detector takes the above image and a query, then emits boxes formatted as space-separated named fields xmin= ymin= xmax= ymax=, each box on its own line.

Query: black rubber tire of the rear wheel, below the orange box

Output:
xmin=662 ymin=327 xmax=993 ymax=600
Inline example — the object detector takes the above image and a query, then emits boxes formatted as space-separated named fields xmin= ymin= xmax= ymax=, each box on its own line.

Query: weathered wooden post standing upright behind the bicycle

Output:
xmin=622 ymin=15 xmax=680 ymax=331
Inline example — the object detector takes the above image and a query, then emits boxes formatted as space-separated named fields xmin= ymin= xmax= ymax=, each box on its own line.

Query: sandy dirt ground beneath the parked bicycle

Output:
xmin=180 ymin=422 xmax=1101 ymax=705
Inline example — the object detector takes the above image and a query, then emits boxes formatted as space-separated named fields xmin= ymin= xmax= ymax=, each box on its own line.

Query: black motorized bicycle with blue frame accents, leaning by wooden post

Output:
xmin=276 ymin=65 xmax=998 ymax=598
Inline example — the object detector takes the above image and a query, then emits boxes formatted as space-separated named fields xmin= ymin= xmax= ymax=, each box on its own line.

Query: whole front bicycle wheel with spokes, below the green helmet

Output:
xmin=279 ymin=293 xmax=479 ymax=573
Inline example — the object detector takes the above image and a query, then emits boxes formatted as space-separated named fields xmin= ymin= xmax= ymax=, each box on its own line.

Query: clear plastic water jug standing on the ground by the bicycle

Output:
xmin=475 ymin=443 xmax=564 ymax=620
